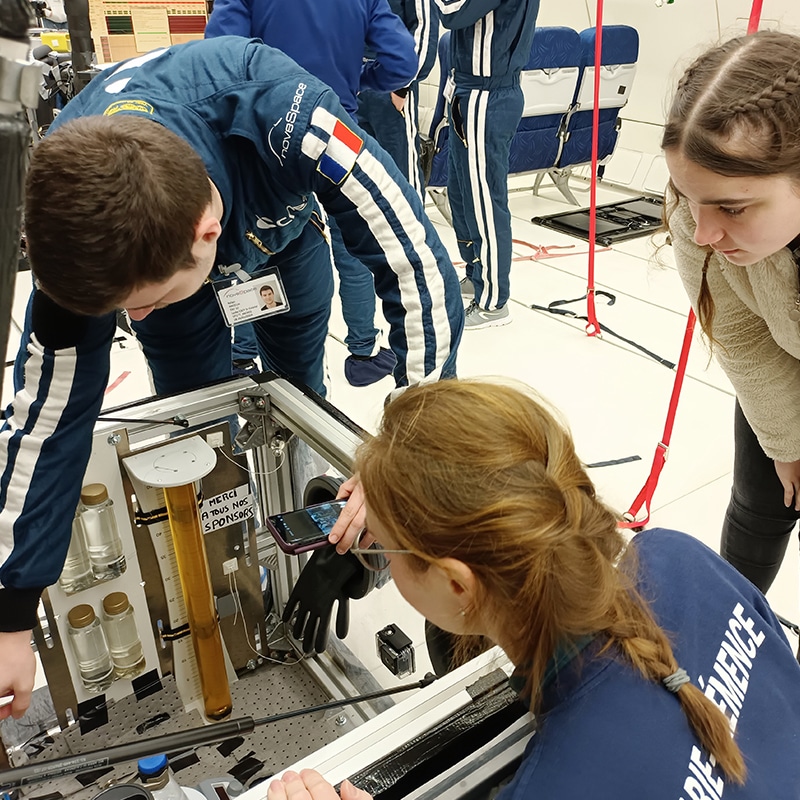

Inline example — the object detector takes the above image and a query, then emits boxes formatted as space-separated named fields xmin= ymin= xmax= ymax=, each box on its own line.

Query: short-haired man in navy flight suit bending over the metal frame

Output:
xmin=0 ymin=37 xmax=463 ymax=716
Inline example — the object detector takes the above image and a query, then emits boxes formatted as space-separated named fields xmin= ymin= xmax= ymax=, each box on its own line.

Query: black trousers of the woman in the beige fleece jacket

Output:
xmin=720 ymin=401 xmax=800 ymax=594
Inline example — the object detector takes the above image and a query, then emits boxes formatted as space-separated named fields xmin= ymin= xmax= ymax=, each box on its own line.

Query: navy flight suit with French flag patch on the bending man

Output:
xmin=0 ymin=37 xmax=463 ymax=631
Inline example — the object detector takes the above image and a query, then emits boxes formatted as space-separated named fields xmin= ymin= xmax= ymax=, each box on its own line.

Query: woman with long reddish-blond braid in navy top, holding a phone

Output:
xmin=268 ymin=380 xmax=800 ymax=800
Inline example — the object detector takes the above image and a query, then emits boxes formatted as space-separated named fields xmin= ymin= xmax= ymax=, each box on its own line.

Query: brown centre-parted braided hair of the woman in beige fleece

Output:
xmin=661 ymin=31 xmax=800 ymax=344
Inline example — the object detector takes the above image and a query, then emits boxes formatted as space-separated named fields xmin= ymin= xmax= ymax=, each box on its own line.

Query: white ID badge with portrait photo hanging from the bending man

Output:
xmin=213 ymin=264 xmax=289 ymax=328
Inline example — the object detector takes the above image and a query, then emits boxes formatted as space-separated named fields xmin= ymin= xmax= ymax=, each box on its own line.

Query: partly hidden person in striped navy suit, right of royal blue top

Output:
xmin=358 ymin=0 xmax=439 ymax=196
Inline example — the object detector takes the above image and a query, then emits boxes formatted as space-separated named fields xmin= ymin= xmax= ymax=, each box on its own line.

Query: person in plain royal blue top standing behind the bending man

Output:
xmin=205 ymin=0 xmax=417 ymax=386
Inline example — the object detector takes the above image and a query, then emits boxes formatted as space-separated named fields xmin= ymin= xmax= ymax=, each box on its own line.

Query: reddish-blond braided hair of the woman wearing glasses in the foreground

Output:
xmin=356 ymin=380 xmax=745 ymax=783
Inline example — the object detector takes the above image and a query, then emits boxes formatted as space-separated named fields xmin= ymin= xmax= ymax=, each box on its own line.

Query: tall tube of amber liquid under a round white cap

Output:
xmin=164 ymin=483 xmax=233 ymax=720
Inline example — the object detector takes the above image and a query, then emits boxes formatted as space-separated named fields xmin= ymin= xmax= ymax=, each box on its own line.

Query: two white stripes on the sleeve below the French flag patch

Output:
xmin=342 ymin=150 xmax=452 ymax=384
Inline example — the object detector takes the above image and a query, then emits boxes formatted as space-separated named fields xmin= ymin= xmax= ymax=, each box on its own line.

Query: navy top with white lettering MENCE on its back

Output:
xmin=497 ymin=528 xmax=800 ymax=800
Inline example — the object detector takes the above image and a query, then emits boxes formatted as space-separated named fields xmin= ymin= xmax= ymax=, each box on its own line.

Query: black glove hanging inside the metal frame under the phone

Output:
xmin=283 ymin=544 xmax=374 ymax=653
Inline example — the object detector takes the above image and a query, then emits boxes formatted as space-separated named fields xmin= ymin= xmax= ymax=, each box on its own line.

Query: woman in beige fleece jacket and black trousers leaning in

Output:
xmin=662 ymin=31 xmax=800 ymax=592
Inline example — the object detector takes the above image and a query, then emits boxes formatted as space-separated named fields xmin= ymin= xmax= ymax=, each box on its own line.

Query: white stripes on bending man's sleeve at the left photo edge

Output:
xmin=0 ymin=336 xmax=78 ymax=584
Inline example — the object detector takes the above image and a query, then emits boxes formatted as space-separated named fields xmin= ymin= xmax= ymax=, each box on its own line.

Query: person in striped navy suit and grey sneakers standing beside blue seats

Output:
xmin=436 ymin=0 xmax=539 ymax=330
